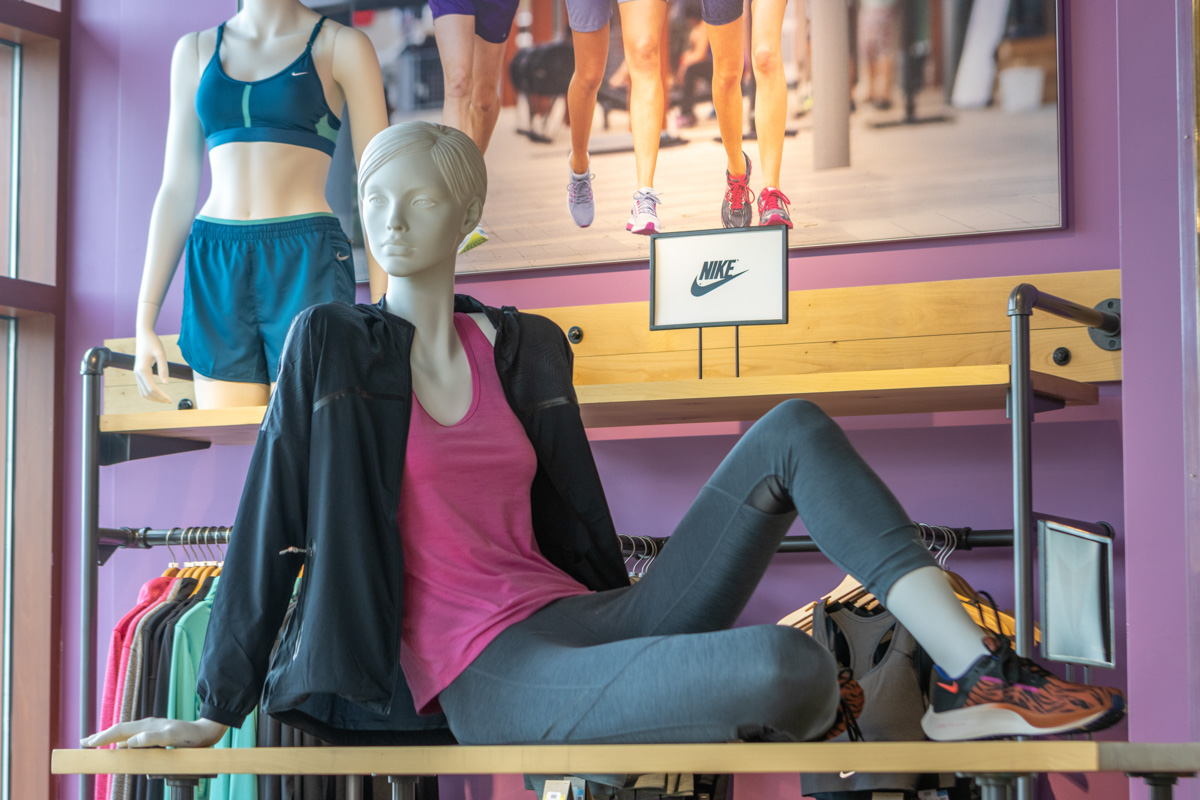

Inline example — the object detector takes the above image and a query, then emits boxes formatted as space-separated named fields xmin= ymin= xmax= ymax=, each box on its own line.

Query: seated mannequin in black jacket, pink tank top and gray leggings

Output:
xmin=82 ymin=122 xmax=1124 ymax=747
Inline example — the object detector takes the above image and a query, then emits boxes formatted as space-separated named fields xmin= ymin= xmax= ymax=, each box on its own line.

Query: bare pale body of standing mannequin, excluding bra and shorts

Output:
xmin=134 ymin=0 xmax=386 ymax=408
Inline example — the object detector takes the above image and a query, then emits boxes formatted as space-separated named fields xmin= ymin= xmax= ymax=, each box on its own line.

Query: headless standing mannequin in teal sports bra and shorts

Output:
xmin=133 ymin=0 xmax=388 ymax=408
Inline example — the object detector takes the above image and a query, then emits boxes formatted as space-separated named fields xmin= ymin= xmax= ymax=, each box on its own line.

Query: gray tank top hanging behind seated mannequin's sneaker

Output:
xmin=800 ymin=603 xmax=954 ymax=795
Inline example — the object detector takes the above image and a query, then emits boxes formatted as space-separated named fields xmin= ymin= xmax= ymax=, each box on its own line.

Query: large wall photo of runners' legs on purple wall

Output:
xmin=338 ymin=0 xmax=1063 ymax=272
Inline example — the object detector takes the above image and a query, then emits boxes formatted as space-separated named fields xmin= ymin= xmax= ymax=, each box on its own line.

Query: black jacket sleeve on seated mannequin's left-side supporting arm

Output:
xmin=197 ymin=309 xmax=322 ymax=728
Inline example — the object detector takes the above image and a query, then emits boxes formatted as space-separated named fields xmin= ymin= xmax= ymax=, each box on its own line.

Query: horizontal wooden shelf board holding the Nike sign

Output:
xmin=100 ymin=365 xmax=1098 ymax=444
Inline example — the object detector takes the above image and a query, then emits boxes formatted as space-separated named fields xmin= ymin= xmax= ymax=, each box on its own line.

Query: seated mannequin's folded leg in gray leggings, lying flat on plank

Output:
xmin=439 ymin=614 xmax=839 ymax=745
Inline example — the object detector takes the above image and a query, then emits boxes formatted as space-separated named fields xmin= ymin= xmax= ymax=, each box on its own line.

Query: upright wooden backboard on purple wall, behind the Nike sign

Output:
xmin=104 ymin=270 xmax=1121 ymax=414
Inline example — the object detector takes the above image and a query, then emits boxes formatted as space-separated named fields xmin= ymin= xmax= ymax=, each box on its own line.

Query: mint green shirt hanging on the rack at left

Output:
xmin=168 ymin=577 xmax=258 ymax=800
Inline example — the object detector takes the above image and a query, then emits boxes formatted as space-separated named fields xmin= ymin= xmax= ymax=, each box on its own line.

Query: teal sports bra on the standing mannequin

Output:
xmin=196 ymin=17 xmax=342 ymax=155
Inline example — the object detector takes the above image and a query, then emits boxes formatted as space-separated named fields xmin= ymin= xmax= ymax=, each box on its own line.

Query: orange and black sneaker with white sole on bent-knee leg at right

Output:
xmin=920 ymin=634 xmax=1126 ymax=741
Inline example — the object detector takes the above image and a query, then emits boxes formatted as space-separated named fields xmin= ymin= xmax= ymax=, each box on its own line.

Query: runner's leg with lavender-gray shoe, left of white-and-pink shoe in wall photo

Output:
xmin=566 ymin=0 xmax=612 ymax=228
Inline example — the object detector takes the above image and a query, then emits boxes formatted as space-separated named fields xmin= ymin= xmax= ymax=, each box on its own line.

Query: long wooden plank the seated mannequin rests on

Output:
xmin=52 ymin=741 xmax=1200 ymax=775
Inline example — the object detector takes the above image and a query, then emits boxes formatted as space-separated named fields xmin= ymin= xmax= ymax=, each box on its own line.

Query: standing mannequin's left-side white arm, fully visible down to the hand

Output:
xmin=133 ymin=34 xmax=204 ymax=402
